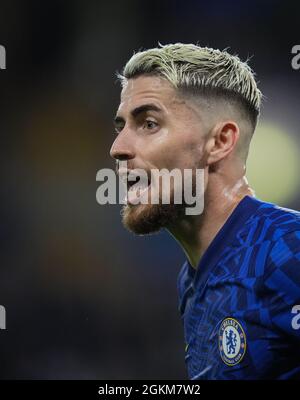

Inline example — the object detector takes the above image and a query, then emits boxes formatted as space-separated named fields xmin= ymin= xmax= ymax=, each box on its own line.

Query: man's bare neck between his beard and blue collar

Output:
xmin=168 ymin=176 xmax=254 ymax=269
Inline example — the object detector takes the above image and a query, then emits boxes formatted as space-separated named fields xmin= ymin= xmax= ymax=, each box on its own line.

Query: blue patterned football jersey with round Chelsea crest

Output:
xmin=177 ymin=196 xmax=300 ymax=380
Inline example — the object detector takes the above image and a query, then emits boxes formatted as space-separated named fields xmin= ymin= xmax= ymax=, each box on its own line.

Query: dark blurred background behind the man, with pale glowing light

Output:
xmin=0 ymin=0 xmax=300 ymax=379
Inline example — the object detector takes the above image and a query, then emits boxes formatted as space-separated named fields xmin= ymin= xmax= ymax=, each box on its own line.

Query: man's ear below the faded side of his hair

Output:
xmin=207 ymin=121 xmax=240 ymax=165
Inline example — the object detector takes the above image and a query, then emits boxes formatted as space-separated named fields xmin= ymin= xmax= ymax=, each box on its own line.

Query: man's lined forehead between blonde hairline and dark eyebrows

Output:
xmin=118 ymin=76 xmax=182 ymax=113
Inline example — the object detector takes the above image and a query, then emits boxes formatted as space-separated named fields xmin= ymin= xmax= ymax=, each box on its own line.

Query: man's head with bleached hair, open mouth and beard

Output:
xmin=111 ymin=43 xmax=261 ymax=234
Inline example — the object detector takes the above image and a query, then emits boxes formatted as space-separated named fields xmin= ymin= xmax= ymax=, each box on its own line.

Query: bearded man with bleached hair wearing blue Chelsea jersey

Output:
xmin=111 ymin=43 xmax=300 ymax=379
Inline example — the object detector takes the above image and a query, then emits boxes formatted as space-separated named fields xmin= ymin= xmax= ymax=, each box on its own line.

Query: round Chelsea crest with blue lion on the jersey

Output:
xmin=219 ymin=318 xmax=246 ymax=366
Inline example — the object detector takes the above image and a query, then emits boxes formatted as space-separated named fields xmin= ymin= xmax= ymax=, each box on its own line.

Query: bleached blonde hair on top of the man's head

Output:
xmin=117 ymin=43 xmax=262 ymax=125
